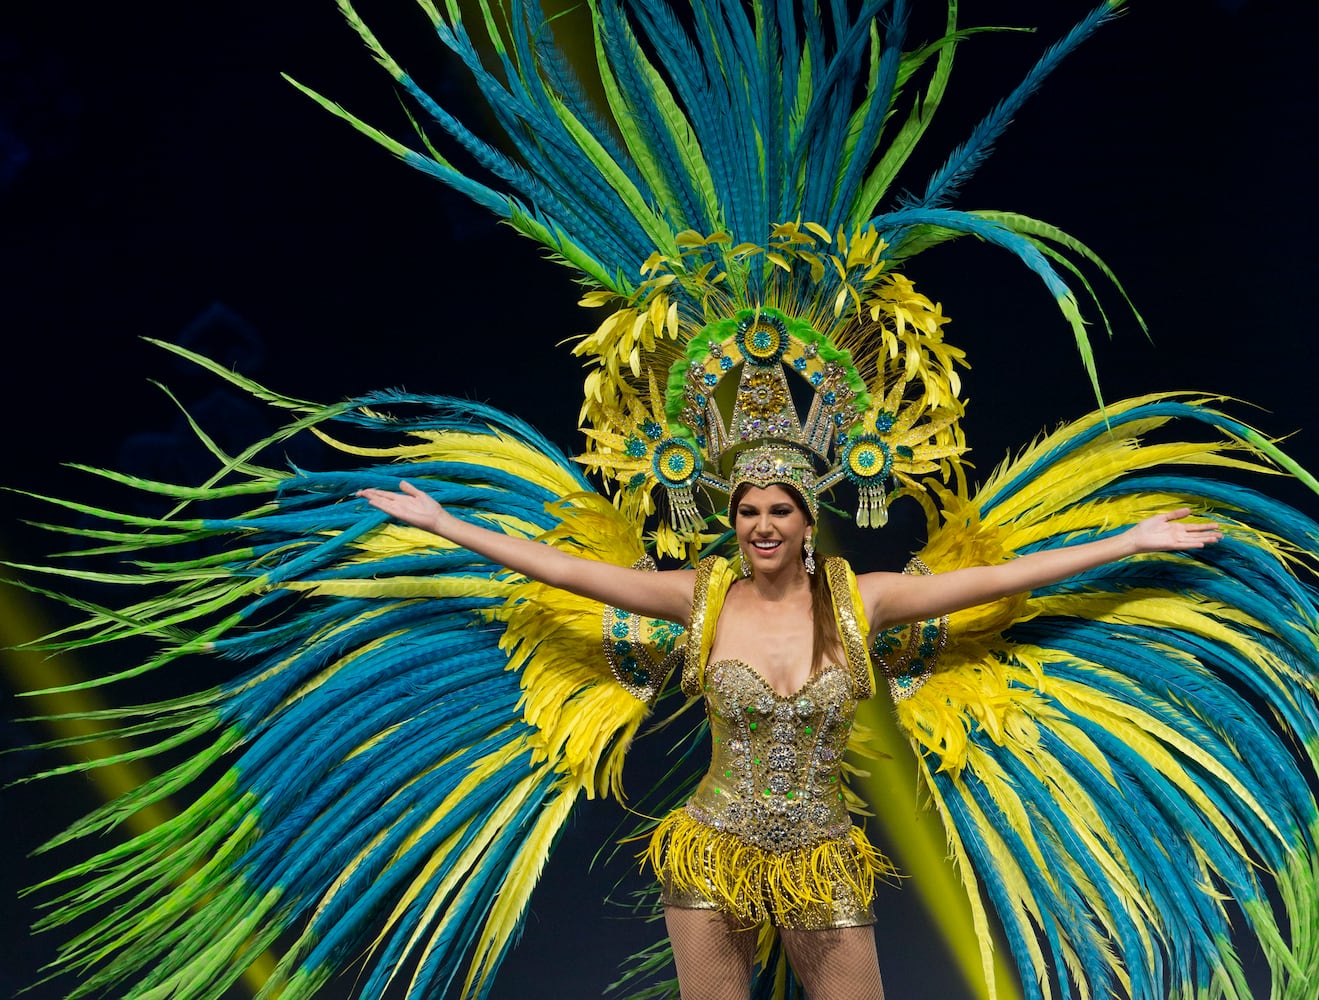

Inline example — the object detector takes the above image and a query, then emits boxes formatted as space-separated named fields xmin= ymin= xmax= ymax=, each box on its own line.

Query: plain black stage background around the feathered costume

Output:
xmin=0 ymin=0 xmax=1319 ymax=1000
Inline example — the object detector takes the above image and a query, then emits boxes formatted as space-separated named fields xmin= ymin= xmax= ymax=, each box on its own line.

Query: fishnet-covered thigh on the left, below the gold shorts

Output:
xmin=663 ymin=906 xmax=756 ymax=1000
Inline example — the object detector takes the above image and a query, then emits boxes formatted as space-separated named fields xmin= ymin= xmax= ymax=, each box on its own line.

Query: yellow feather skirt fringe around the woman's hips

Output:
xmin=646 ymin=809 xmax=898 ymax=930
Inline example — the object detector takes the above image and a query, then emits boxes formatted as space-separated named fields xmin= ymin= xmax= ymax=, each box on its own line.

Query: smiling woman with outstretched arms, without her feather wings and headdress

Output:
xmin=360 ymin=462 xmax=1223 ymax=1000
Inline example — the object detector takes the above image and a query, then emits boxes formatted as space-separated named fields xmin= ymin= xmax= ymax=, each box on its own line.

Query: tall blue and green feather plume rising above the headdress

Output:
xmin=299 ymin=0 xmax=1120 ymax=397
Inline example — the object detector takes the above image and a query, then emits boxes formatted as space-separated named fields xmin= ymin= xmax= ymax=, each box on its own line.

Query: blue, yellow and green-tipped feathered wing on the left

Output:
xmin=15 ymin=348 xmax=673 ymax=997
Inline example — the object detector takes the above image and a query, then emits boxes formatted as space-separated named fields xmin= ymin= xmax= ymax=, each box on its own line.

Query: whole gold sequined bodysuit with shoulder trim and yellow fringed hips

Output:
xmin=649 ymin=561 xmax=893 ymax=929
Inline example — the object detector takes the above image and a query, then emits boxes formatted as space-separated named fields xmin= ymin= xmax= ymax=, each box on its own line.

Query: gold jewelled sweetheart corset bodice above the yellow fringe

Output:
xmin=687 ymin=660 xmax=856 ymax=852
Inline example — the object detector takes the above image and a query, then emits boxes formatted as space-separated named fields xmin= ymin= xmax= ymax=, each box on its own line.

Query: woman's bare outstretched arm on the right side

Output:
xmin=857 ymin=507 xmax=1223 ymax=628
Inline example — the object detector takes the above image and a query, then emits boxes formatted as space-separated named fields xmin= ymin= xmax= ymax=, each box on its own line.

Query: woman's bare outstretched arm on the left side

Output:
xmin=357 ymin=482 xmax=696 ymax=623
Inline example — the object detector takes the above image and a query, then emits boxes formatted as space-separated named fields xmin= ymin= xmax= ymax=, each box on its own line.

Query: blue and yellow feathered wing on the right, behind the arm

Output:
xmin=872 ymin=396 xmax=1319 ymax=1000
